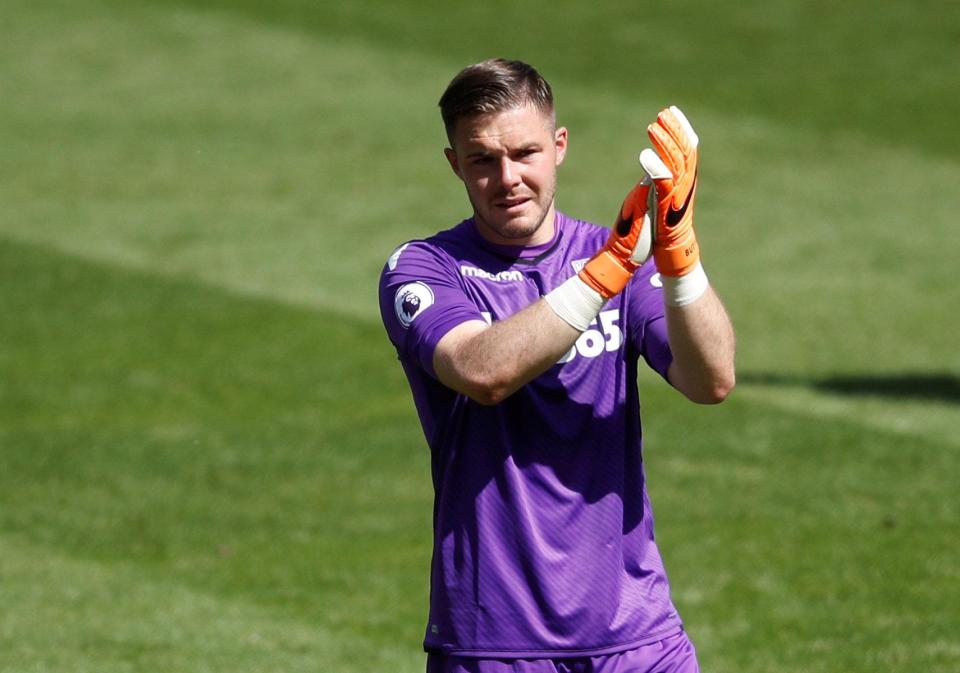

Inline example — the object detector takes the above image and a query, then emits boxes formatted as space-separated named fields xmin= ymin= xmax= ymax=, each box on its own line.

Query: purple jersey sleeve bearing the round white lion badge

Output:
xmin=380 ymin=241 xmax=483 ymax=378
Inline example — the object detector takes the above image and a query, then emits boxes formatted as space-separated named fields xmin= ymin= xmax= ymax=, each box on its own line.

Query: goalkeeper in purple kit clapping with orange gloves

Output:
xmin=380 ymin=59 xmax=734 ymax=673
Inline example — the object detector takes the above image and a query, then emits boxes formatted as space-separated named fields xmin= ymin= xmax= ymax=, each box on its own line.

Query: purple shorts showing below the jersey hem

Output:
xmin=427 ymin=631 xmax=700 ymax=673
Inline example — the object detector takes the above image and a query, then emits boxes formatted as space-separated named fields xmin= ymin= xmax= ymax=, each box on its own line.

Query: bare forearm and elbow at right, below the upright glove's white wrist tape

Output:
xmin=666 ymin=288 xmax=736 ymax=404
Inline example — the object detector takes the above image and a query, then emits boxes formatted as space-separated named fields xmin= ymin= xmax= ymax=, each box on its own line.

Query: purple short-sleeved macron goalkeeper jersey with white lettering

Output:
xmin=380 ymin=213 xmax=681 ymax=658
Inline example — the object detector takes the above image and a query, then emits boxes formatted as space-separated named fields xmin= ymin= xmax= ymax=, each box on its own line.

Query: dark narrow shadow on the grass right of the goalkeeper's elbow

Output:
xmin=737 ymin=372 xmax=960 ymax=404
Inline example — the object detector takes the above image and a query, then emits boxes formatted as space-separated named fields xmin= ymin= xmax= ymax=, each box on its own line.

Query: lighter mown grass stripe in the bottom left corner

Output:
xmin=0 ymin=534 xmax=423 ymax=673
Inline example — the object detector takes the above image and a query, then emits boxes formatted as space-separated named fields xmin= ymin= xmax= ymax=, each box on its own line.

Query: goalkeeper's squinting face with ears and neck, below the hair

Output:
xmin=445 ymin=106 xmax=567 ymax=245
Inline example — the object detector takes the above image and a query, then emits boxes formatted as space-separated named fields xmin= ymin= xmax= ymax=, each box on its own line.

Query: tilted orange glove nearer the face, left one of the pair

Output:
xmin=579 ymin=177 xmax=653 ymax=299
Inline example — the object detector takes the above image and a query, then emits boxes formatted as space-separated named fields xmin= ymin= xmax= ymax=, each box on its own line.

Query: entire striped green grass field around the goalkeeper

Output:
xmin=0 ymin=0 xmax=960 ymax=673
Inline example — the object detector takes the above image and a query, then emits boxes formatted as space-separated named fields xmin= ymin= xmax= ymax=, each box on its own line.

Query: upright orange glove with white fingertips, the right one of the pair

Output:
xmin=640 ymin=106 xmax=700 ymax=277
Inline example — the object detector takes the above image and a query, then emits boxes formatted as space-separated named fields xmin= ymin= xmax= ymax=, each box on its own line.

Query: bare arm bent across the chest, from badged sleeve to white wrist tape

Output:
xmin=433 ymin=299 xmax=580 ymax=404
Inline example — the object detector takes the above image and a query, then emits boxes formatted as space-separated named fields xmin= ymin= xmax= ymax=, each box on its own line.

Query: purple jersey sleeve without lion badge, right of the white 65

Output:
xmin=625 ymin=263 xmax=673 ymax=380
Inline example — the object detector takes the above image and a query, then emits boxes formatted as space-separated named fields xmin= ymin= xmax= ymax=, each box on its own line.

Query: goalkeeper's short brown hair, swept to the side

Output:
xmin=440 ymin=58 xmax=554 ymax=141
